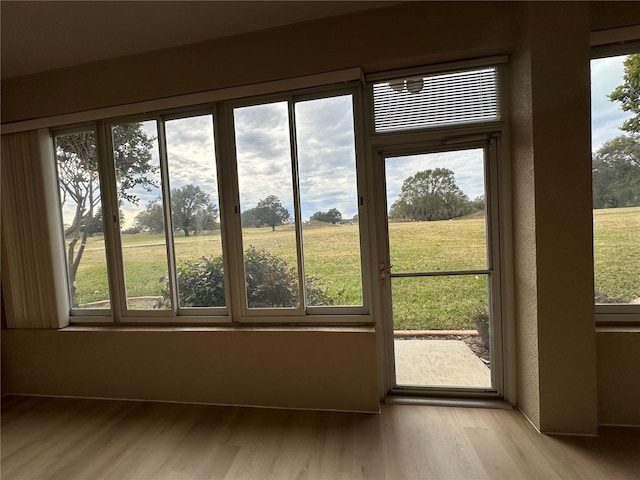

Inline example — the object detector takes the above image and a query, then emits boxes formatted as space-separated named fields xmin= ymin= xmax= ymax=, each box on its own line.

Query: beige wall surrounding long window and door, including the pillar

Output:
xmin=2 ymin=2 xmax=640 ymax=433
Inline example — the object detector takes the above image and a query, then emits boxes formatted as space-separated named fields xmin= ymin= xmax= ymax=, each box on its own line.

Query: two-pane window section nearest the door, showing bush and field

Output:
xmin=233 ymin=95 xmax=363 ymax=309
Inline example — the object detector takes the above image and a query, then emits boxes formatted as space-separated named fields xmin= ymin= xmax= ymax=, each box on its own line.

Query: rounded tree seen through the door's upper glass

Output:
xmin=389 ymin=168 xmax=469 ymax=221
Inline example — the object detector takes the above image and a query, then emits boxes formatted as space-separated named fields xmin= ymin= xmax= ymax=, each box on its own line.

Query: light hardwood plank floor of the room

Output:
xmin=0 ymin=396 xmax=640 ymax=480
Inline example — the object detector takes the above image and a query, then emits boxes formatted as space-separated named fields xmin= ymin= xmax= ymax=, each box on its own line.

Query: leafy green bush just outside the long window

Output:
xmin=156 ymin=247 xmax=334 ymax=308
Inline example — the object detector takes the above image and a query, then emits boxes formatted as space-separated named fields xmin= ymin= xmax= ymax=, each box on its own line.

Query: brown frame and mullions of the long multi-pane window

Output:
xmin=50 ymin=81 xmax=373 ymax=326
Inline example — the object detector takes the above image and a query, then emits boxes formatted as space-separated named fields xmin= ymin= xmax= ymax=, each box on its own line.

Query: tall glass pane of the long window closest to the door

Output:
xmin=295 ymin=95 xmax=362 ymax=306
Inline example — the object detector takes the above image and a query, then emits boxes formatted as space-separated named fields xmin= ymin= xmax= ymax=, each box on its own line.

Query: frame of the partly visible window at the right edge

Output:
xmin=589 ymin=42 xmax=640 ymax=326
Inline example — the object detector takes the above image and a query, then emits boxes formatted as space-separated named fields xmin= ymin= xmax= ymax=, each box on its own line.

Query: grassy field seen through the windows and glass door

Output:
xmin=76 ymin=207 xmax=640 ymax=329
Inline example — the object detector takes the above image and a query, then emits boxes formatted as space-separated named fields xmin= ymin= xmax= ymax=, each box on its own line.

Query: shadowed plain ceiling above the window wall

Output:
xmin=0 ymin=0 xmax=395 ymax=79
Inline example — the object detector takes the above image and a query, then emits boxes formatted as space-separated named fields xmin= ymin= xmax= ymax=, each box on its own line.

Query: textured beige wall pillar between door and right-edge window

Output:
xmin=511 ymin=2 xmax=597 ymax=433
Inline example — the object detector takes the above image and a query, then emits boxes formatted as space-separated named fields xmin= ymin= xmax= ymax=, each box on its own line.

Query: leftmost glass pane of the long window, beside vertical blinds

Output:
xmin=55 ymin=131 xmax=110 ymax=309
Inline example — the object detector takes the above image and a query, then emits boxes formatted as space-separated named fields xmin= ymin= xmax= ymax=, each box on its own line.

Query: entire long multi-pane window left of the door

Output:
xmin=54 ymin=87 xmax=367 ymax=322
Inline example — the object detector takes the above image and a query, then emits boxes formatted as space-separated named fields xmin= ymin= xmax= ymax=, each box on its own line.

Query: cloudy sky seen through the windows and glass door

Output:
xmin=110 ymin=57 xmax=630 ymax=225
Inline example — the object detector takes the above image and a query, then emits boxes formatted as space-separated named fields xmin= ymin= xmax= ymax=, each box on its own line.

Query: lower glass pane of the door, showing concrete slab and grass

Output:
xmin=391 ymin=275 xmax=491 ymax=388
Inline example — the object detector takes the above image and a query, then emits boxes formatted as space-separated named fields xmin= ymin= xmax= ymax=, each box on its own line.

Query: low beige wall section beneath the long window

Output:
xmin=2 ymin=328 xmax=378 ymax=412
